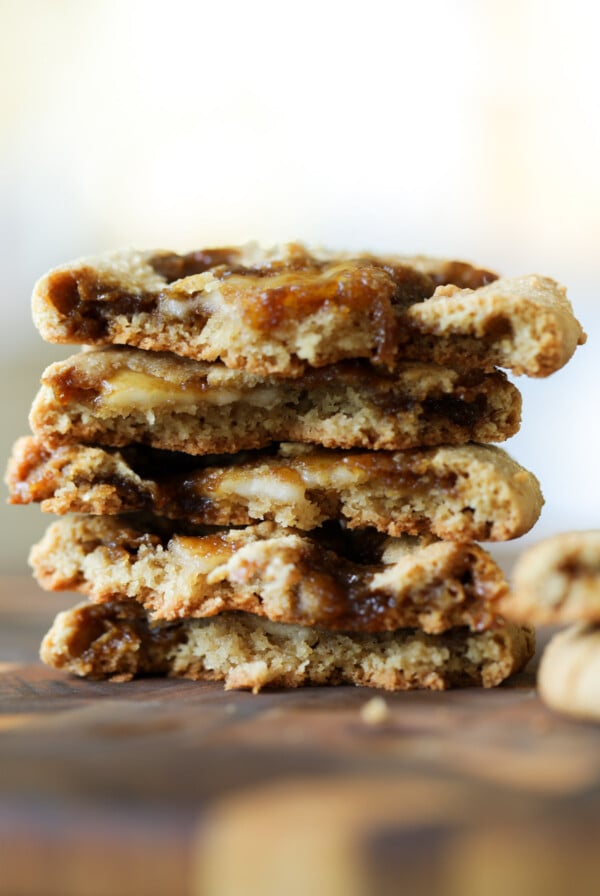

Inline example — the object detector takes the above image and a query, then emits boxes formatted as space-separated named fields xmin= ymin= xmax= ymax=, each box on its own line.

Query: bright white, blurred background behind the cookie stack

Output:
xmin=0 ymin=0 xmax=600 ymax=572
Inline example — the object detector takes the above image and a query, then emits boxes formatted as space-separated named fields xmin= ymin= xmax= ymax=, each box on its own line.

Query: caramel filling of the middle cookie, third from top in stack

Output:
xmin=10 ymin=445 xmax=468 ymax=522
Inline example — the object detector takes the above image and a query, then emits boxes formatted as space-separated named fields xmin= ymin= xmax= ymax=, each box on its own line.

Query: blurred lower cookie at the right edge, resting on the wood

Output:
xmin=538 ymin=624 xmax=600 ymax=720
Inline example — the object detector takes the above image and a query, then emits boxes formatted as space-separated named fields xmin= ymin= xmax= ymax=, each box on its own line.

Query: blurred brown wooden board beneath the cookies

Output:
xmin=0 ymin=578 xmax=600 ymax=896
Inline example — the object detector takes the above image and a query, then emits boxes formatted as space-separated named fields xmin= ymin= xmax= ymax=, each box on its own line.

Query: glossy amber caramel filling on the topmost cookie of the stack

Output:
xmin=46 ymin=246 xmax=495 ymax=366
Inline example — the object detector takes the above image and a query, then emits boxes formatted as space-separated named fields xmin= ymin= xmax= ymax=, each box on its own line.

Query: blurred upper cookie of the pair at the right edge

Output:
xmin=503 ymin=529 xmax=600 ymax=625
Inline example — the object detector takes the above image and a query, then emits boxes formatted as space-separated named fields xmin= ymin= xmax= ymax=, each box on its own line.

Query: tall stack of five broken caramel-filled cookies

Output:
xmin=7 ymin=245 xmax=585 ymax=691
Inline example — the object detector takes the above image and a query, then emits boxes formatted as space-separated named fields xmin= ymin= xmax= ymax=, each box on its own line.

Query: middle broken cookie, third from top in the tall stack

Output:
xmin=6 ymin=437 xmax=543 ymax=541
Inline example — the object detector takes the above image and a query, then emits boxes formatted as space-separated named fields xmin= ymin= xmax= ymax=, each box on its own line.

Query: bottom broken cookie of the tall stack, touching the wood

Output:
xmin=41 ymin=601 xmax=534 ymax=693
